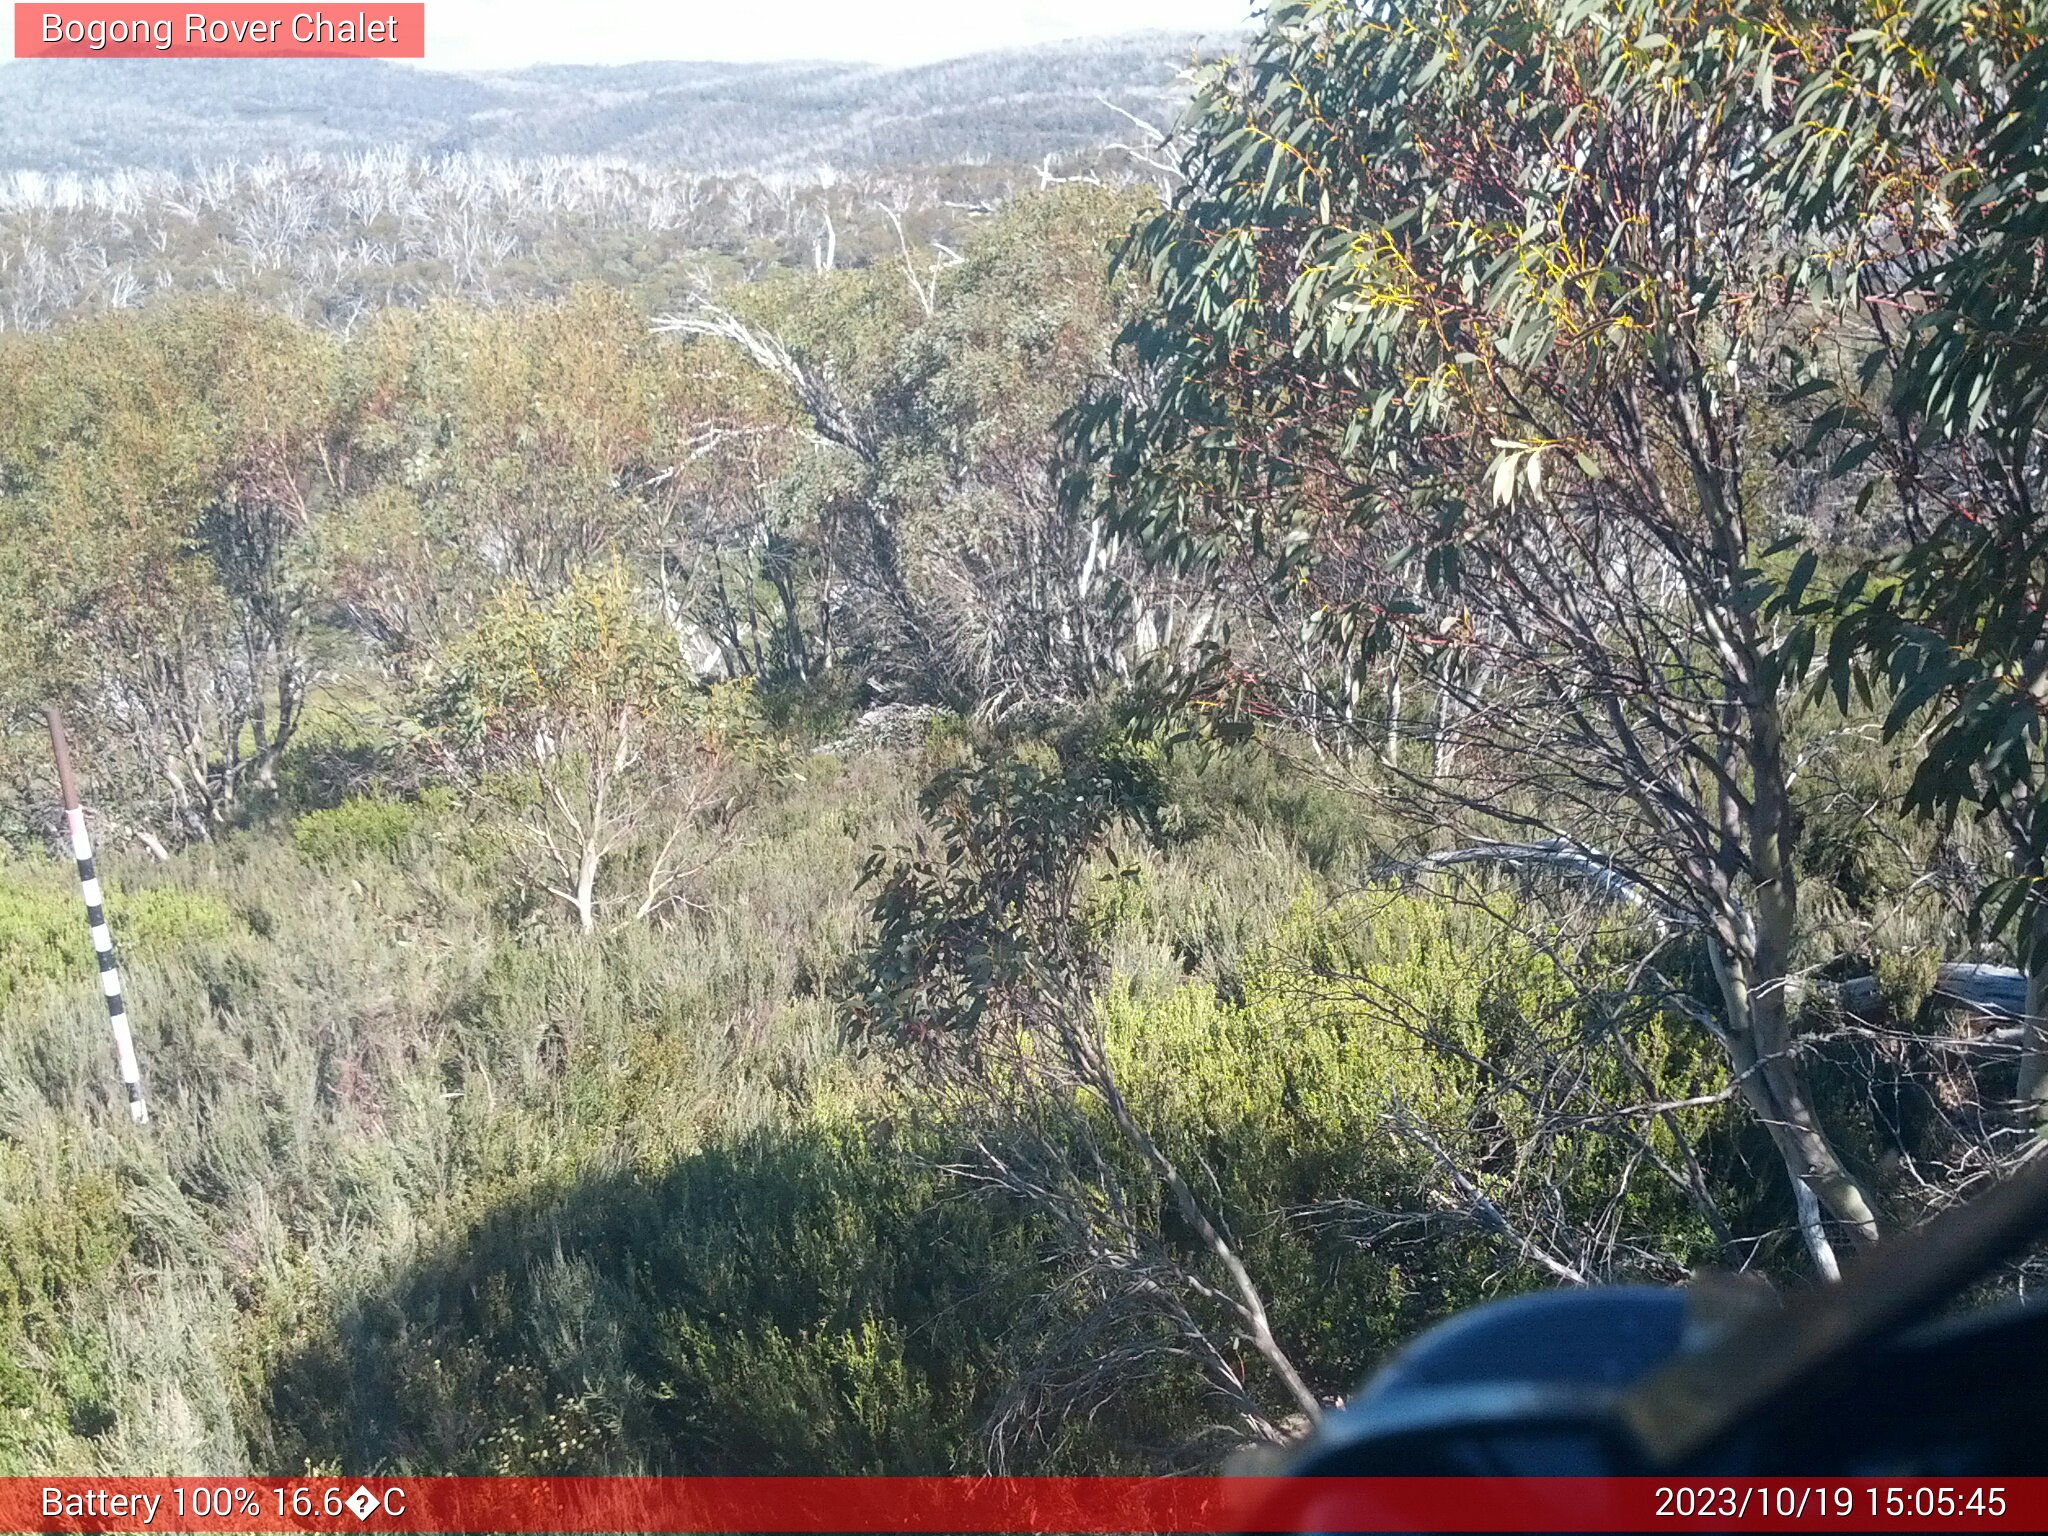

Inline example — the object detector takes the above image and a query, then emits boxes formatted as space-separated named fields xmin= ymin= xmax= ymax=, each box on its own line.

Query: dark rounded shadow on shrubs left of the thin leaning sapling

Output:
xmin=264 ymin=1126 xmax=1073 ymax=1475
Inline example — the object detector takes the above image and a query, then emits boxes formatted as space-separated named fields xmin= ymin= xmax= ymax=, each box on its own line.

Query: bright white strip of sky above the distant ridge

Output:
xmin=413 ymin=0 xmax=1251 ymax=70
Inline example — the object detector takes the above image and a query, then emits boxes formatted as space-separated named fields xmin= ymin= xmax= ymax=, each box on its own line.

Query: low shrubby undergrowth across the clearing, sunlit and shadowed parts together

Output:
xmin=0 ymin=758 xmax=1744 ymax=1473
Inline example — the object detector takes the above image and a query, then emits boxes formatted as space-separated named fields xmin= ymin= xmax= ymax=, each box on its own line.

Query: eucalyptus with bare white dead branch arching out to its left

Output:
xmin=657 ymin=186 xmax=1163 ymax=713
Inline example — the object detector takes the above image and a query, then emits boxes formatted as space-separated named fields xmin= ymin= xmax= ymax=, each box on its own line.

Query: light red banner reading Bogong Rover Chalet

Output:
xmin=14 ymin=4 xmax=426 ymax=59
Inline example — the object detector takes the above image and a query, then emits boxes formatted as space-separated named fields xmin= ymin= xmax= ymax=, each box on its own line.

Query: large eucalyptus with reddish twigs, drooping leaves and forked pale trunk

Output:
xmin=1075 ymin=0 xmax=1878 ymax=1272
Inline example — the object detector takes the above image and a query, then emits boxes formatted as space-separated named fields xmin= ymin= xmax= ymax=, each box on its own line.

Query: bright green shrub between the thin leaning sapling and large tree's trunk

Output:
xmin=1106 ymin=889 xmax=1726 ymax=1393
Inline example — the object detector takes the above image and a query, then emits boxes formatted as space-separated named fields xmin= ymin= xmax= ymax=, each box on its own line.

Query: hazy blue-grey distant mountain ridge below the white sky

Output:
xmin=0 ymin=33 xmax=1237 ymax=172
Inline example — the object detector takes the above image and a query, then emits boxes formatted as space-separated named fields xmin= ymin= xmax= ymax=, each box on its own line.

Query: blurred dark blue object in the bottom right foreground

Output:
xmin=1290 ymin=1157 xmax=2048 ymax=1477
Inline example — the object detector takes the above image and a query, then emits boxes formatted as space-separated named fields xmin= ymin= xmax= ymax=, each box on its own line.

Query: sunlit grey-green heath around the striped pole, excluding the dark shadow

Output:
xmin=0 ymin=766 xmax=921 ymax=1475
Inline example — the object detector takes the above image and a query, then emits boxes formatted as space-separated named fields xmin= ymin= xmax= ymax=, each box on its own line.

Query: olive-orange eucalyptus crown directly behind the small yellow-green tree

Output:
xmin=324 ymin=289 xmax=702 ymax=672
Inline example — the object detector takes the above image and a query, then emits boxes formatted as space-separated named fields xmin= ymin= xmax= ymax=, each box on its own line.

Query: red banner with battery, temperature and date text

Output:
xmin=0 ymin=1477 xmax=2048 ymax=1536
